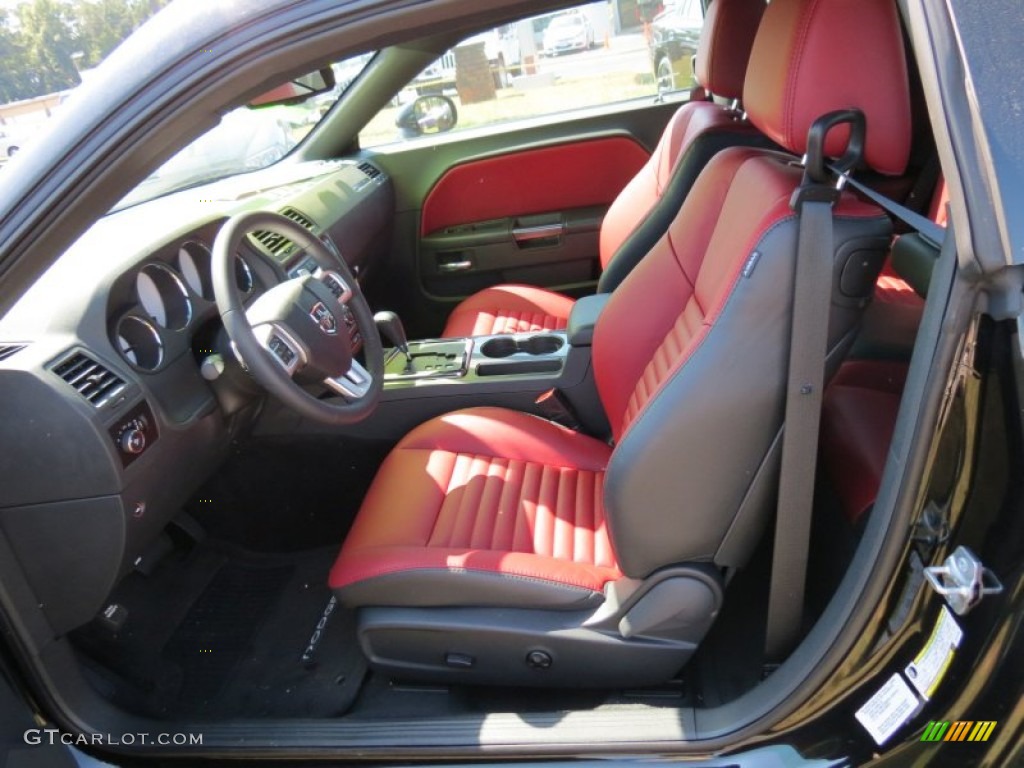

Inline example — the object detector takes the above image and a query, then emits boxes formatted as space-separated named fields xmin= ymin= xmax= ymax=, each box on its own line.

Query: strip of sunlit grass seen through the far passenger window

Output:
xmin=359 ymin=73 xmax=656 ymax=146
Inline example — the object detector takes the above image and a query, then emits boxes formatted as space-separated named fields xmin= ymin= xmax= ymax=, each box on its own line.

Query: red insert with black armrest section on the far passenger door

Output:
xmin=419 ymin=136 xmax=649 ymax=297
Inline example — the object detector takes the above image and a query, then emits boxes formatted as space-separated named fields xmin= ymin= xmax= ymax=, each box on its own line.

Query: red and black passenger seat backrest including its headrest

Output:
xmin=598 ymin=0 xmax=773 ymax=293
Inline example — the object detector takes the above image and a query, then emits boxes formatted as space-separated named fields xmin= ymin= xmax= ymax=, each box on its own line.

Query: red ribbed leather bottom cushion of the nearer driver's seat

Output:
xmin=330 ymin=408 xmax=622 ymax=609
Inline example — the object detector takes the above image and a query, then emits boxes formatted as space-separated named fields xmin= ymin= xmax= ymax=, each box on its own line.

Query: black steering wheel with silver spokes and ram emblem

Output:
xmin=212 ymin=211 xmax=384 ymax=424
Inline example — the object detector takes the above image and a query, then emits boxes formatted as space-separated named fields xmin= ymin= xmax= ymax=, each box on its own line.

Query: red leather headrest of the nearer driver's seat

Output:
xmin=743 ymin=0 xmax=910 ymax=175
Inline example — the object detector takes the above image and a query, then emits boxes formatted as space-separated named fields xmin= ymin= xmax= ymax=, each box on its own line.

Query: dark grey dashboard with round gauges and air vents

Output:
xmin=0 ymin=160 xmax=394 ymax=634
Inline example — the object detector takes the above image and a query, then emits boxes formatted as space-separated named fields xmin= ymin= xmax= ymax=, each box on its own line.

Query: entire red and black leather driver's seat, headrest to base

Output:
xmin=330 ymin=0 xmax=910 ymax=686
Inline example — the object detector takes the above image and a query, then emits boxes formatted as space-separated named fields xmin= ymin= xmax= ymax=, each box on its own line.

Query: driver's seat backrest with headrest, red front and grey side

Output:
xmin=593 ymin=0 xmax=910 ymax=578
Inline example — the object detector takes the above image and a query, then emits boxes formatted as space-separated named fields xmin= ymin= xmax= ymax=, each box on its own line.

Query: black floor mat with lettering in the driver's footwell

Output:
xmin=72 ymin=544 xmax=366 ymax=719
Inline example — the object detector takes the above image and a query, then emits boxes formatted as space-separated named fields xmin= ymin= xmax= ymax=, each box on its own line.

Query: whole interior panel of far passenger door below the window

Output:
xmin=365 ymin=101 xmax=679 ymax=337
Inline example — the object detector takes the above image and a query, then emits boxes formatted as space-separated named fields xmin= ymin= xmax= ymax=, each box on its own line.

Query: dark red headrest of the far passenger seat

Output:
xmin=693 ymin=0 xmax=765 ymax=98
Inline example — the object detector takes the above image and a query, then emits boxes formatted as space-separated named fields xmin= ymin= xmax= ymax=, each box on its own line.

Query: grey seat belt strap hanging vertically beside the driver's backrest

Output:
xmin=765 ymin=189 xmax=834 ymax=660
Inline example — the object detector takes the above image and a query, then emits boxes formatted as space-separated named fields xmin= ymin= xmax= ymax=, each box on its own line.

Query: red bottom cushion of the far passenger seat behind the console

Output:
xmin=441 ymin=285 xmax=575 ymax=338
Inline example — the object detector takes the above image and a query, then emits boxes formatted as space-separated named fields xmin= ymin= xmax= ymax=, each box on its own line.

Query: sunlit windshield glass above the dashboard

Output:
xmin=117 ymin=53 xmax=374 ymax=209
